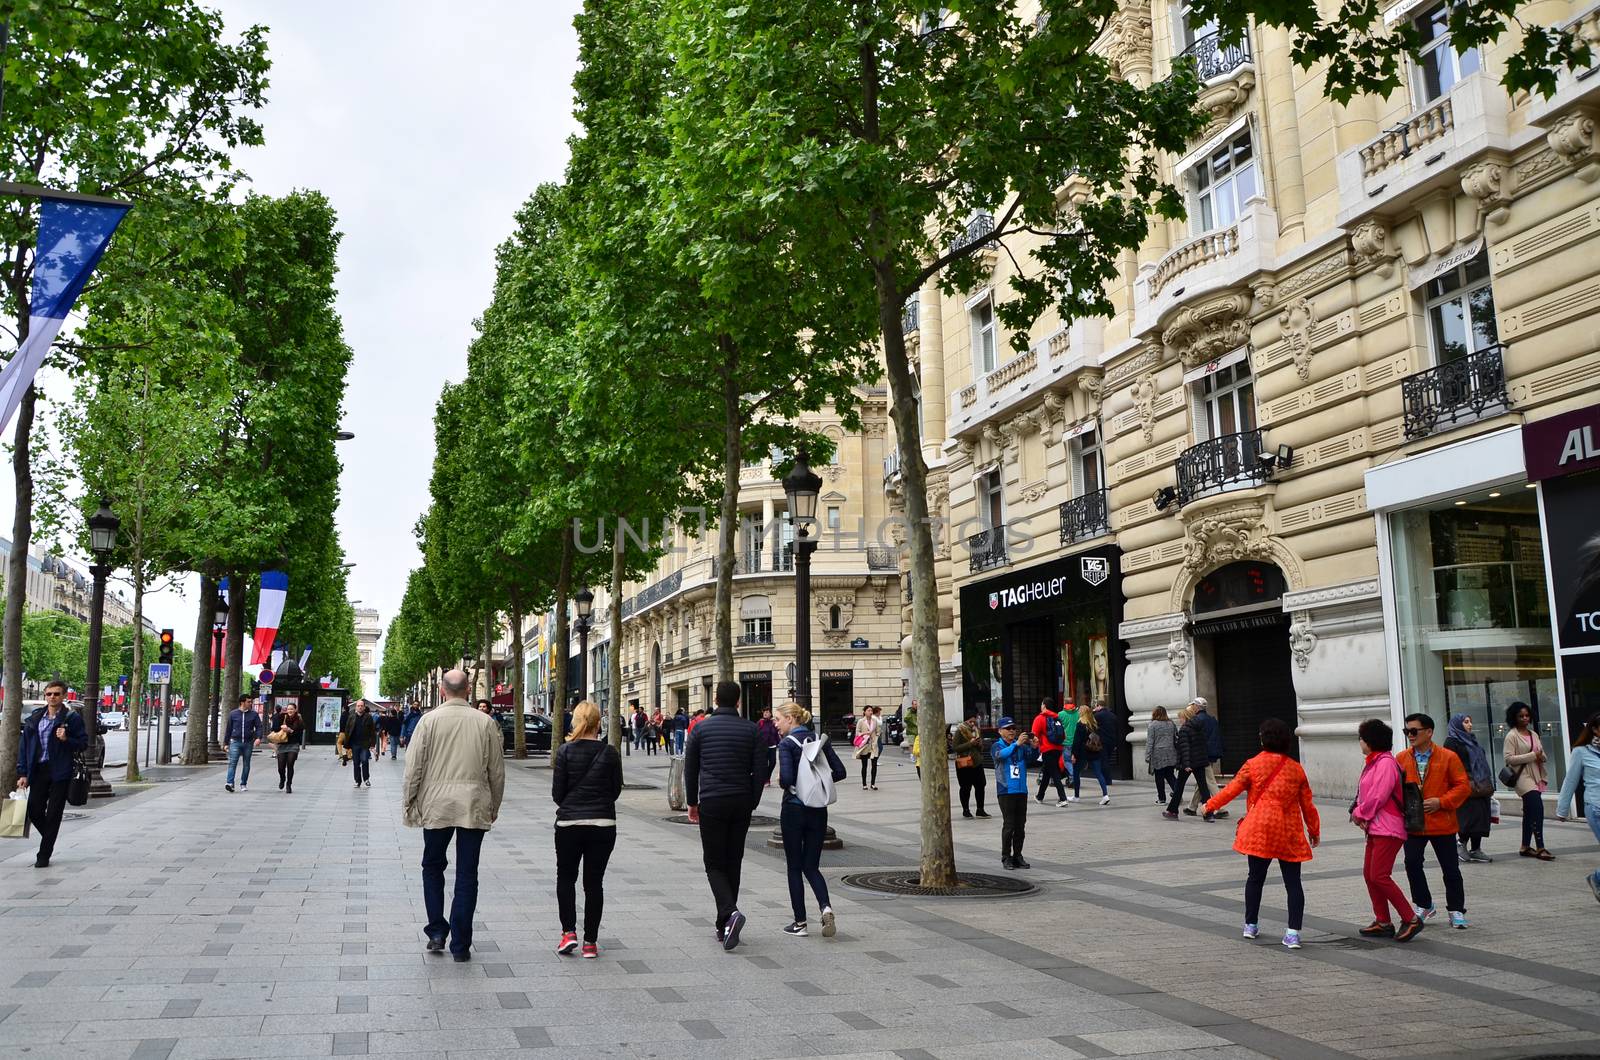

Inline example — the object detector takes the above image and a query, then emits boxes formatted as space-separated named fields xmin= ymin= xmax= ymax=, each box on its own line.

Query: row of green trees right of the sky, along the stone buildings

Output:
xmin=396 ymin=0 xmax=1589 ymax=885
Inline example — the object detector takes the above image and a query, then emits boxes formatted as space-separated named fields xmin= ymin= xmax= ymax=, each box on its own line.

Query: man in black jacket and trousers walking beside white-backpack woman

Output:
xmin=683 ymin=681 xmax=770 ymax=950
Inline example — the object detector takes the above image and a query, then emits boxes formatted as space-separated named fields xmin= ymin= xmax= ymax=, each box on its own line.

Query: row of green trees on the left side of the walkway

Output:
xmin=0 ymin=0 xmax=358 ymax=788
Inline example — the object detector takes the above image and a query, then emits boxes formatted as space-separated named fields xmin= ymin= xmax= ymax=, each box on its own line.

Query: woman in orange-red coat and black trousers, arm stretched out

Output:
xmin=1205 ymin=717 xmax=1322 ymax=950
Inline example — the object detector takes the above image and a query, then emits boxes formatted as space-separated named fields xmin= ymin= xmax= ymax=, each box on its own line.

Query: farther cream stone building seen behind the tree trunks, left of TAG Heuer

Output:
xmin=611 ymin=403 xmax=902 ymax=736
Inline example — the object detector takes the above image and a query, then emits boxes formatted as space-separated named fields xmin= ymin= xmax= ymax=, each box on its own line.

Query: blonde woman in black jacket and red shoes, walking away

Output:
xmin=550 ymin=700 xmax=622 ymax=958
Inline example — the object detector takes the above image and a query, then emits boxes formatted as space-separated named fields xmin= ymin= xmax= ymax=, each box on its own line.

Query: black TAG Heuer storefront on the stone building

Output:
xmin=962 ymin=544 xmax=1126 ymax=775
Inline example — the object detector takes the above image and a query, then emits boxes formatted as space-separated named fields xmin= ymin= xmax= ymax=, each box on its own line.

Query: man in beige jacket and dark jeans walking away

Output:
xmin=403 ymin=669 xmax=506 ymax=961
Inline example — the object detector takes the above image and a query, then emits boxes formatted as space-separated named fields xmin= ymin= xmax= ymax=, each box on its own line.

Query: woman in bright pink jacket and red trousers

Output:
xmin=1350 ymin=717 xmax=1422 ymax=942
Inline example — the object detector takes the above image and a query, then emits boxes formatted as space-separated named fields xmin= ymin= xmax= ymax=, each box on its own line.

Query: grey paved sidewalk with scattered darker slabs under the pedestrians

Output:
xmin=0 ymin=751 xmax=1600 ymax=1060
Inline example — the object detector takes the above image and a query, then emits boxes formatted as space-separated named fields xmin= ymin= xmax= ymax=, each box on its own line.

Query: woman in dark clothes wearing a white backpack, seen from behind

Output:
xmin=773 ymin=703 xmax=848 ymax=938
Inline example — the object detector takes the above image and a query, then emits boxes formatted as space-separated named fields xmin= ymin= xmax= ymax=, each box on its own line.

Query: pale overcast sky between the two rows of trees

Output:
xmin=0 ymin=0 xmax=581 ymax=675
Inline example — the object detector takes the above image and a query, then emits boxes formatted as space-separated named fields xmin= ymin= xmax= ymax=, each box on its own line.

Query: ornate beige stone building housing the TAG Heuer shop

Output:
xmin=888 ymin=0 xmax=1600 ymax=791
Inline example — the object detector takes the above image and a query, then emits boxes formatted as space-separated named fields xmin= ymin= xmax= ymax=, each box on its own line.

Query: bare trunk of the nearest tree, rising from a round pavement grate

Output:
xmin=875 ymin=263 xmax=955 ymax=887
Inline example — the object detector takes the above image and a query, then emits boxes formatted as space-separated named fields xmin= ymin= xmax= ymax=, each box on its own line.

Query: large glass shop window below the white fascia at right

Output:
xmin=1389 ymin=484 xmax=1565 ymax=783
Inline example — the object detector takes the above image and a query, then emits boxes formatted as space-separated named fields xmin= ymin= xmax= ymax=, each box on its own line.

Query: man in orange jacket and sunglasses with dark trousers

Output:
xmin=1395 ymin=714 xmax=1472 ymax=929
